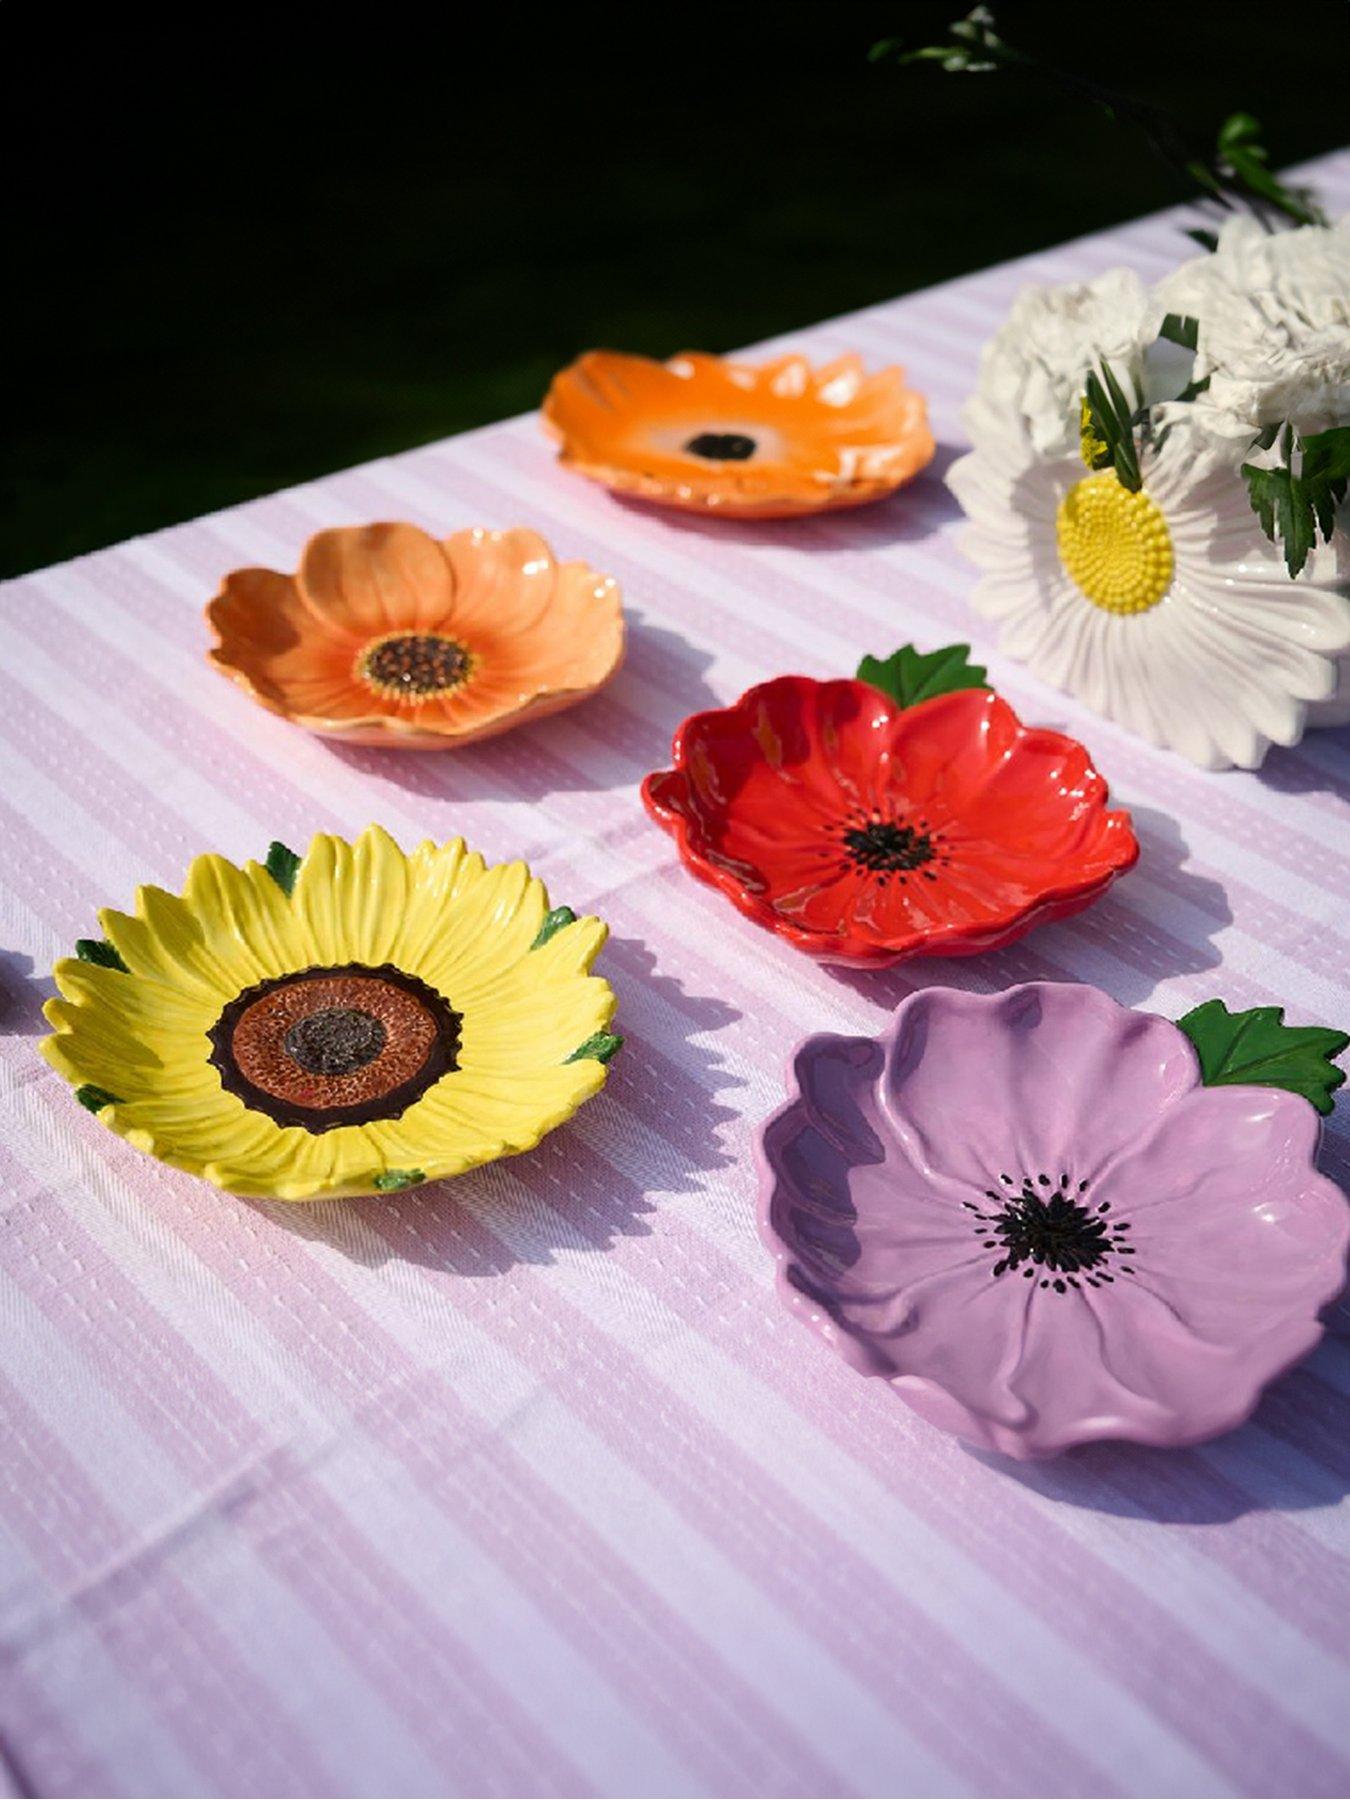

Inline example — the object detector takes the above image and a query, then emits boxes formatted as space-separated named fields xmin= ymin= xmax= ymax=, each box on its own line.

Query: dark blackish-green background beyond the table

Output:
xmin=0 ymin=0 xmax=1348 ymax=574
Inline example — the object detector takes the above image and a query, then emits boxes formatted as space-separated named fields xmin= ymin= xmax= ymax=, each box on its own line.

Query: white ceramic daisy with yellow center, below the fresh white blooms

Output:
xmin=947 ymin=409 xmax=1350 ymax=769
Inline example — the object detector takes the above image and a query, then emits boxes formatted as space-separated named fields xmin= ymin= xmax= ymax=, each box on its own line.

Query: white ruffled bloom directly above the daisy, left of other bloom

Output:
xmin=963 ymin=268 xmax=1163 ymax=455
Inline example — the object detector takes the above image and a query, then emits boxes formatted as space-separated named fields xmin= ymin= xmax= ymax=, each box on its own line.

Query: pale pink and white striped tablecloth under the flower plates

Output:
xmin=0 ymin=155 xmax=1350 ymax=1795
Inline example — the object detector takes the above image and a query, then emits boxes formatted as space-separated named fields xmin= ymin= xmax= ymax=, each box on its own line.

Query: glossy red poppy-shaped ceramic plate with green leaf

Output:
xmin=643 ymin=644 xmax=1139 ymax=967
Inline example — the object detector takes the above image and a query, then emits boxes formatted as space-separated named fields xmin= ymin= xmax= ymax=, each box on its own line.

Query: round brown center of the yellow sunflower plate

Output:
xmin=207 ymin=963 xmax=463 ymax=1132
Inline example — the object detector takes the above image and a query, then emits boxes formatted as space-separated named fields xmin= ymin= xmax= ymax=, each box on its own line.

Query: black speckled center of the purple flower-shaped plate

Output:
xmin=961 ymin=1174 xmax=1134 ymax=1294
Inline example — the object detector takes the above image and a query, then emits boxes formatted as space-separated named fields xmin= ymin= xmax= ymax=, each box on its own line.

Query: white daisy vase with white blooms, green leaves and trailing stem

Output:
xmin=871 ymin=5 xmax=1350 ymax=769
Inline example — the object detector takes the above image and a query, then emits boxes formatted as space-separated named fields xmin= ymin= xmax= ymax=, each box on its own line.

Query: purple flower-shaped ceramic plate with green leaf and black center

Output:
xmin=760 ymin=983 xmax=1350 ymax=1458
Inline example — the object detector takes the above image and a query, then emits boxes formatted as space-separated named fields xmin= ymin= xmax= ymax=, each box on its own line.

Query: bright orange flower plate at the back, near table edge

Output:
xmin=544 ymin=351 xmax=932 ymax=518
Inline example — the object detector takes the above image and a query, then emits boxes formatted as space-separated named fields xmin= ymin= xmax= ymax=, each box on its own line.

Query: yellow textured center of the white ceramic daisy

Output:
xmin=1055 ymin=468 xmax=1172 ymax=612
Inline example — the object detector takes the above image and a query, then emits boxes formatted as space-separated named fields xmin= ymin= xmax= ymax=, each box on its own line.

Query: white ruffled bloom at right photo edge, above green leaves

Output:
xmin=1159 ymin=214 xmax=1350 ymax=437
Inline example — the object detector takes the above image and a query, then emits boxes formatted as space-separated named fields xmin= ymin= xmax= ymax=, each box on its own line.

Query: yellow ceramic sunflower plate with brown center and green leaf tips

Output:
xmin=41 ymin=826 xmax=623 ymax=1201
